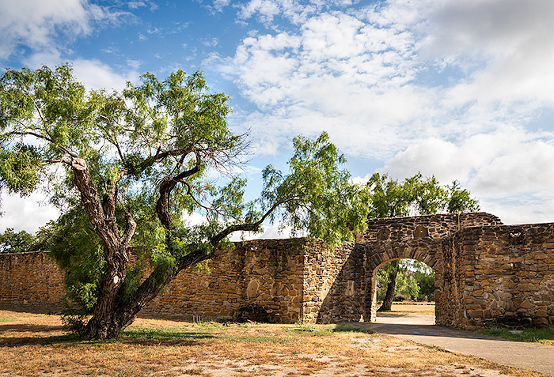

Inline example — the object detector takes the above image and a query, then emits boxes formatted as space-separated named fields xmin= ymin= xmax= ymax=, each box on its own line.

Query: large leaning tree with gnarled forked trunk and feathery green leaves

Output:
xmin=0 ymin=65 xmax=368 ymax=339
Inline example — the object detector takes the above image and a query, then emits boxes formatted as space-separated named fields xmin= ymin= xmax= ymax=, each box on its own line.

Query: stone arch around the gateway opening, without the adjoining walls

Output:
xmin=360 ymin=213 xmax=501 ymax=324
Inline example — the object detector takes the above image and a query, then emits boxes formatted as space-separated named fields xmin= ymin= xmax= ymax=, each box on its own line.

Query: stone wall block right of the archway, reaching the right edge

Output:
xmin=452 ymin=224 xmax=554 ymax=329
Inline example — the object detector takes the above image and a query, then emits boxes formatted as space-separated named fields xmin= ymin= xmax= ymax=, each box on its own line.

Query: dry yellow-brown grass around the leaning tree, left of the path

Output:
xmin=0 ymin=311 xmax=540 ymax=377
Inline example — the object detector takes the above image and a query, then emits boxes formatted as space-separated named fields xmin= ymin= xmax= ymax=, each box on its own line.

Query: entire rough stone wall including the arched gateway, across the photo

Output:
xmin=0 ymin=213 xmax=554 ymax=329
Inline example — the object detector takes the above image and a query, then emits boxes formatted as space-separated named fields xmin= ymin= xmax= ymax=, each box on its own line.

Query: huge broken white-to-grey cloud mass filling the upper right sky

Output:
xmin=217 ymin=0 xmax=554 ymax=159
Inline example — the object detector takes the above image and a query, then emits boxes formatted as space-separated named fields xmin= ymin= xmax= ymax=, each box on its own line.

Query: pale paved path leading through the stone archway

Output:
xmin=356 ymin=314 xmax=554 ymax=375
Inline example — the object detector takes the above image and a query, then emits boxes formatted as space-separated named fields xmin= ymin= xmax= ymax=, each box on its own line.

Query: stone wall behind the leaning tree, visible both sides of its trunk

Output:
xmin=0 ymin=239 xmax=306 ymax=323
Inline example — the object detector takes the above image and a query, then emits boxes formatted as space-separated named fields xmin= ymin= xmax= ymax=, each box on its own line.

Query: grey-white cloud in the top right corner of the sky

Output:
xmin=421 ymin=0 xmax=554 ymax=116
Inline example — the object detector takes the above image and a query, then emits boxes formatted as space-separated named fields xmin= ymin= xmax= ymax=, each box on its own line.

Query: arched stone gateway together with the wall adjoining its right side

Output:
xmin=310 ymin=213 xmax=554 ymax=329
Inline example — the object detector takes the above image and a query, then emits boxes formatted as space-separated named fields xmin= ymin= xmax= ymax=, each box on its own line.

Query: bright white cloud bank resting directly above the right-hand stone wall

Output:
xmin=380 ymin=126 xmax=554 ymax=224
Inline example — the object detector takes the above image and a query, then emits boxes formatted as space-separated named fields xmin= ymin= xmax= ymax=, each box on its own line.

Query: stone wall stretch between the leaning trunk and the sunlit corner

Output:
xmin=142 ymin=239 xmax=305 ymax=323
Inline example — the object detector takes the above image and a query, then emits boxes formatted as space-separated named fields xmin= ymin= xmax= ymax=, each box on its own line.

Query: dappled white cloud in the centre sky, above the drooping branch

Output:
xmin=215 ymin=6 xmax=435 ymax=157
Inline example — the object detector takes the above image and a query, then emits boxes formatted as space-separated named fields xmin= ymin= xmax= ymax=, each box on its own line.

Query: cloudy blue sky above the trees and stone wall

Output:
xmin=0 ymin=0 xmax=554 ymax=235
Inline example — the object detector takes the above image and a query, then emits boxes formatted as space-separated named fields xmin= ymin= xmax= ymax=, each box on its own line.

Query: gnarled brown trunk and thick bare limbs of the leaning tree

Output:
xmin=74 ymin=151 xmax=292 ymax=339
